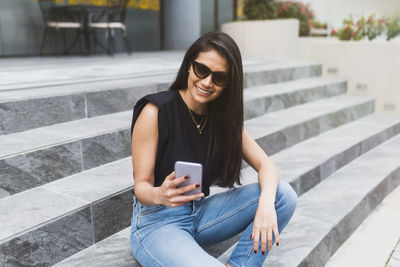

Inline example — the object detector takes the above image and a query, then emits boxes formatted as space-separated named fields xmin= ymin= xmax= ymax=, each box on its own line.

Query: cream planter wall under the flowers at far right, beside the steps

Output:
xmin=311 ymin=38 xmax=400 ymax=115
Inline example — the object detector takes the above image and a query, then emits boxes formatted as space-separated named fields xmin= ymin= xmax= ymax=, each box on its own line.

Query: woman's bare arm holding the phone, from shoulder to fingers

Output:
xmin=132 ymin=103 xmax=204 ymax=207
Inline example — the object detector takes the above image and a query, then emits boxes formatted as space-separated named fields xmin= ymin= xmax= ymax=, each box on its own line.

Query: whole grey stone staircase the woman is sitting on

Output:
xmin=0 ymin=57 xmax=400 ymax=266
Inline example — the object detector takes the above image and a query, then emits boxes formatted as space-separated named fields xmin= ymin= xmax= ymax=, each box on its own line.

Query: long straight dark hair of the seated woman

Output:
xmin=170 ymin=31 xmax=243 ymax=187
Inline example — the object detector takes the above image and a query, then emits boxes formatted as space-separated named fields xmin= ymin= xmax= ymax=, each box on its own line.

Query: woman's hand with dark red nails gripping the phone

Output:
xmin=156 ymin=171 xmax=204 ymax=207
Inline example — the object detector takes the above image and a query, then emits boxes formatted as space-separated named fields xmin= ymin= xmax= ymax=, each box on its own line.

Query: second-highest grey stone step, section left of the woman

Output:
xmin=0 ymin=111 xmax=132 ymax=198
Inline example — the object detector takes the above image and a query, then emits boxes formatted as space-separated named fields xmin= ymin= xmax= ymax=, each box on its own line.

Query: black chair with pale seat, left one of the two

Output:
xmin=39 ymin=0 xmax=85 ymax=55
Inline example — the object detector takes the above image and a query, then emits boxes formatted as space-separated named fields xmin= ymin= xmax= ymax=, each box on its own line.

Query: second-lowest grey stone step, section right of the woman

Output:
xmin=214 ymin=113 xmax=400 ymax=196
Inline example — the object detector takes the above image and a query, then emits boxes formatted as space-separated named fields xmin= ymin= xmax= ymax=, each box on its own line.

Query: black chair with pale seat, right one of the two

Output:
xmin=88 ymin=0 xmax=131 ymax=55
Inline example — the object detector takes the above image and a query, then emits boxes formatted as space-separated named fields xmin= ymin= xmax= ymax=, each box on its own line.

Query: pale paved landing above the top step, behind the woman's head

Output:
xmin=0 ymin=51 xmax=274 ymax=92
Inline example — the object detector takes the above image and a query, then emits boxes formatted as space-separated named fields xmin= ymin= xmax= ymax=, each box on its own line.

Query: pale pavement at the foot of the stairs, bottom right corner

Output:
xmin=326 ymin=186 xmax=400 ymax=267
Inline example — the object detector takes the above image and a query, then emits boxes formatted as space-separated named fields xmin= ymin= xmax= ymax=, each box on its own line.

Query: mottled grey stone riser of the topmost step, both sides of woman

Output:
xmin=0 ymin=62 xmax=322 ymax=134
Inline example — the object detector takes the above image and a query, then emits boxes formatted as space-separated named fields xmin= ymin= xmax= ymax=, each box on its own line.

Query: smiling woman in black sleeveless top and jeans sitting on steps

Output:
xmin=131 ymin=32 xmax=297 ymax=266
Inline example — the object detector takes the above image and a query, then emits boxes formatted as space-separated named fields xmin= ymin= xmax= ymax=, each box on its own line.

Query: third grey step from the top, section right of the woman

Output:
xmin=244 ymin=95 xmax=374 ymax=157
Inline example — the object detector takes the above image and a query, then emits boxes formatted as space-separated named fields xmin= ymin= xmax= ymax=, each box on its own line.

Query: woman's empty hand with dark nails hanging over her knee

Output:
xmin=251 ymin=199 xmax=279 ymax=254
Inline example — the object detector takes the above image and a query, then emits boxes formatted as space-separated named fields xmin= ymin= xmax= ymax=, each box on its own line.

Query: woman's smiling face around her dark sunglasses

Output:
xmin=180 ymin=49 xmax=229 ymax=114
